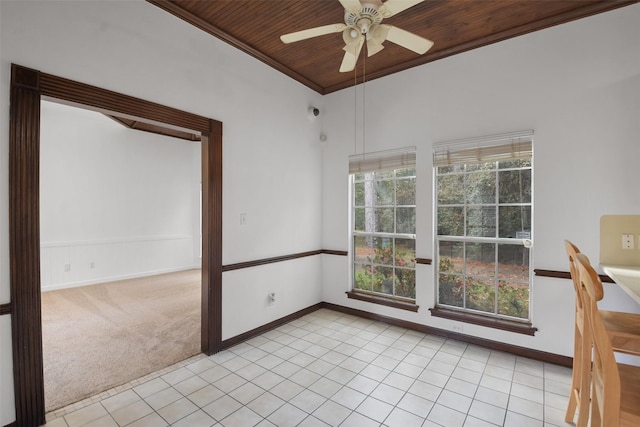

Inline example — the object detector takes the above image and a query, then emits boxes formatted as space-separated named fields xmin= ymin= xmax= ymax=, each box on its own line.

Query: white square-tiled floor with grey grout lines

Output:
xmin=47 ymin=309 xmax=571 ymax=427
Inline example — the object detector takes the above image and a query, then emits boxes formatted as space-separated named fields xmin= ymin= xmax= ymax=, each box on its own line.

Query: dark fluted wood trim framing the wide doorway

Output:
xmin=9 ymin=64 xmax=222 ymax=426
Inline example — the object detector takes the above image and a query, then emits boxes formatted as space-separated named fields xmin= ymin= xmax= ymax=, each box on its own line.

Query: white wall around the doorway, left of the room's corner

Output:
xmin=0 ymin=0 xmax=323 ymax=425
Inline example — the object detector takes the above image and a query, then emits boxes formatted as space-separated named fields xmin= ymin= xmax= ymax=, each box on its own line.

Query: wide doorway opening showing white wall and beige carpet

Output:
xmin=40 ymin=101 xmax=201 ymax=413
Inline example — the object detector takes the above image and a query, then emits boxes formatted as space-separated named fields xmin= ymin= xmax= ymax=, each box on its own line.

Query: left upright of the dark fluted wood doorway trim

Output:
xmin=9 ymin=65 xmax=46 ymax=426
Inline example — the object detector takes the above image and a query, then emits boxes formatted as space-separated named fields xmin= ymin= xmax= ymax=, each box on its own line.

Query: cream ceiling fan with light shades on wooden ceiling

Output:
xmin=280 ymin=0 xmax=433 ymax=72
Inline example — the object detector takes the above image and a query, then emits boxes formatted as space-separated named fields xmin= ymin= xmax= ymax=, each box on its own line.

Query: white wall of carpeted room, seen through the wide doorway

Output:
xmin=40 ymin=101 xmax=201 ymax=290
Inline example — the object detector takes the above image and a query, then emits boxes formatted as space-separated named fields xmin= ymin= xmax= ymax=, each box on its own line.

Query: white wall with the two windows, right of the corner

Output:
xmin=322 ymin=5 xmax=640 ymax=355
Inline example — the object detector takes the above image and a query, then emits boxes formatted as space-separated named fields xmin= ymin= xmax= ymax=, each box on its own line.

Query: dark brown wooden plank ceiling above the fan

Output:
xmin=147 ymin=0 xmax=639 ymax=94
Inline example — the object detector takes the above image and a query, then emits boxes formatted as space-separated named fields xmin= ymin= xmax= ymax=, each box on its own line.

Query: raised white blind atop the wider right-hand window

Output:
xmin=433 ymin=130 xmax=533 ymax=167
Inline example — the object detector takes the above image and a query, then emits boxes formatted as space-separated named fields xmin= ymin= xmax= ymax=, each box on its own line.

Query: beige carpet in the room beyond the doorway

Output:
xmin=42 ymin=270 xmax=201 ymax=412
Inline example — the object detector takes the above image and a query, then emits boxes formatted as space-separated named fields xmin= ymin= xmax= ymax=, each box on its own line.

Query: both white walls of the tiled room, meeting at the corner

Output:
xmin=0 ymin=1 xmax=640 ymax=425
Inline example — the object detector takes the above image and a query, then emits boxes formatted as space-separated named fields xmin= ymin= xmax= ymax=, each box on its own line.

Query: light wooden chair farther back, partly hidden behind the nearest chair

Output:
xmin=564 ymin=240 xmax=640 ymax=427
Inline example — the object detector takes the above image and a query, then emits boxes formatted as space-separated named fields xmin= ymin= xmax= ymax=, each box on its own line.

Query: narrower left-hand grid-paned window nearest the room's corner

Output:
xmin=349 ymin=149 xmax=416 ymax=303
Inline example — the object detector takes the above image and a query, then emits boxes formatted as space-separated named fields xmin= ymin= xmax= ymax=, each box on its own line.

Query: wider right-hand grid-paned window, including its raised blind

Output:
xmin=434 ymin=132 xmax=533 ymax=320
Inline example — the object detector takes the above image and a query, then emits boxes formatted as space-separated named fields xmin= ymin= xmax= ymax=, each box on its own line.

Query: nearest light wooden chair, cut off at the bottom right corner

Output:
xmin=576 ymin=253 xmax=640 ymax=427
